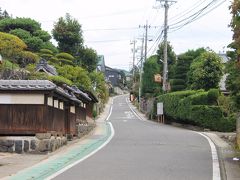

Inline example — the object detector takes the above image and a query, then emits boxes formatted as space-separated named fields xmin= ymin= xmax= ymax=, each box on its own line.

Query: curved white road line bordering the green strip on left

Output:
xmin=46 ymin=109 xmax=115 ymax=180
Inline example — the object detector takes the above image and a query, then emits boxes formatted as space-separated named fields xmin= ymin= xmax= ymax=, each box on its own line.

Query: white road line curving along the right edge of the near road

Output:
xmin=196 ymin=132 xmax=221 ymax=180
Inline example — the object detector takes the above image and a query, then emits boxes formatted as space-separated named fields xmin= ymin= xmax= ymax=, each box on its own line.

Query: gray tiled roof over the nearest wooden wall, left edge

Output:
xmin=0 ymin=80 xmax=56 ymax=90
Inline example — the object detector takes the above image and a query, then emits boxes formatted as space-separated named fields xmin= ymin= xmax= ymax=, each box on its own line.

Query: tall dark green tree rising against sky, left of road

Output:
xmin=52 ymin=14 xmax=83 ymax=56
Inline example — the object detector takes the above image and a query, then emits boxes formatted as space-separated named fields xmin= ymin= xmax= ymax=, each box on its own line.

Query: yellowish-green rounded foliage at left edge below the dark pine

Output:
xmin=0 ymin=32 xmax=27 ymax=58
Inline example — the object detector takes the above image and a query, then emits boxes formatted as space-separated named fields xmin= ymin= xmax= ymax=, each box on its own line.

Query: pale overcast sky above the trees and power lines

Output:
xmin=0 ymin=0 xmax=232 ymax=70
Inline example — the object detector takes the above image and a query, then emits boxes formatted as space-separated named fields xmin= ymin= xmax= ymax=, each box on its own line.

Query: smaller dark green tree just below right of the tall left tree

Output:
xmin=77 ymin=47 xmax=98 ymax=72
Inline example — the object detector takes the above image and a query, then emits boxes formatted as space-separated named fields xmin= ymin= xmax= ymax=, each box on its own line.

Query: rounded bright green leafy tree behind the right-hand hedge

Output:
xmin=188 ymin=52 xmax=223 ymax=90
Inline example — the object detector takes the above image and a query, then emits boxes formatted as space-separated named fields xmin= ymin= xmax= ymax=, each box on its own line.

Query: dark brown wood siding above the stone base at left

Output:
xmin=0 ymin=104 xmax=66 ymax=135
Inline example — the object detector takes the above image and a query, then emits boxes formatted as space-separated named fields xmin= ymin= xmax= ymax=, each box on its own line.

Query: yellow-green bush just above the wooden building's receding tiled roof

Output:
xmin=58 ymin=65 xmax=92 ymax=90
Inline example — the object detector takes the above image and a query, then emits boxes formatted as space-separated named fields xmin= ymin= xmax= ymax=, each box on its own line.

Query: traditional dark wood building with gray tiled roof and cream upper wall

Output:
xmin=0 ymin=80 xmax=95 ymax=135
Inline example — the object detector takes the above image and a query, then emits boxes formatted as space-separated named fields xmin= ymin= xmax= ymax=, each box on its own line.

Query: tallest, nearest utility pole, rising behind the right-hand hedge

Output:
xmin=156 ymin=0 xmax=176 ymax=92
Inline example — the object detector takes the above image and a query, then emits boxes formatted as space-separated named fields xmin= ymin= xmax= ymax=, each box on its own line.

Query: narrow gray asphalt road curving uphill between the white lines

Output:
xmin=55 ymin=96 xmax=212 ymax=180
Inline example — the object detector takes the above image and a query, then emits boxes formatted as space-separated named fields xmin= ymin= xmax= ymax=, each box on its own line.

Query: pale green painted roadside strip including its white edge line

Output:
xmin=9 ymin=122 xmax=114 ymax=180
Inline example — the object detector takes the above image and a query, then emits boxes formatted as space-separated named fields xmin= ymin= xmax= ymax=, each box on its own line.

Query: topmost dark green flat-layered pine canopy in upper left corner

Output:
xmin=0 ymin=18 xmax=41 ymax=33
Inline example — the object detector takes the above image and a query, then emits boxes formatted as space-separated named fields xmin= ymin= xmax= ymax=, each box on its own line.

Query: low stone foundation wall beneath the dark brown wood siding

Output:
xmin=0 ymin=133 xmax=67 ymax=154
